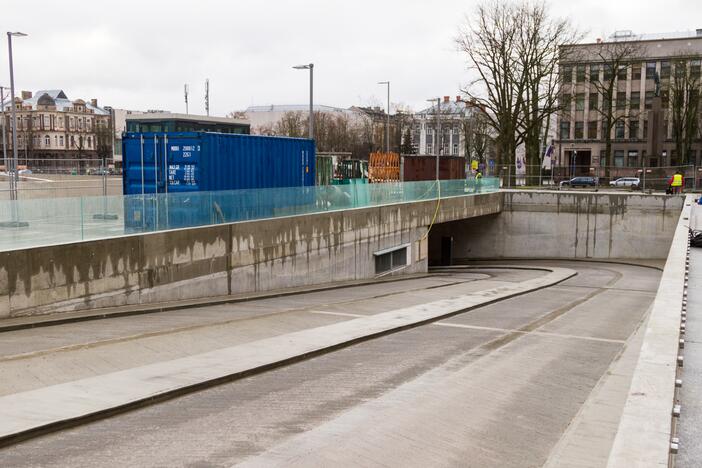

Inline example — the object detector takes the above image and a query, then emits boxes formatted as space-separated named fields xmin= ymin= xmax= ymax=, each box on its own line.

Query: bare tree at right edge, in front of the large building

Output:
xmin=670 ymin=55 xmax=701 ymax=164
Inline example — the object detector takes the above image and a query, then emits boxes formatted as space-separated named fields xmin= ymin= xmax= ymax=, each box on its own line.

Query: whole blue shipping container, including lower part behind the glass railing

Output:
xmin=122 ymin=132 xmax=315 ymax=232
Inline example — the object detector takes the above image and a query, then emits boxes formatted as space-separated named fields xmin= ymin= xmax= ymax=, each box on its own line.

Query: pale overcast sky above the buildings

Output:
xmin=0 ymin=0 xmax=702 ymax=115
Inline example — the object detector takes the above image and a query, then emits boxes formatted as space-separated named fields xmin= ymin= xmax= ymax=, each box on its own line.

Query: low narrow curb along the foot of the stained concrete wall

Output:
xmin=0 ymin=274 xmax=429 ymax=333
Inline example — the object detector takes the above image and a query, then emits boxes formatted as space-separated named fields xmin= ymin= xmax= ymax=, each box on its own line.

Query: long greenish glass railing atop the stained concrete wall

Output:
xmin=0 ymin=178 xmax=499 ymax=251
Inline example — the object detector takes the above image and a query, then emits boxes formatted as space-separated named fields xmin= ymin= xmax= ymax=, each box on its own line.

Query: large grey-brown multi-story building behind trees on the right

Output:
xmin=555 ymin=30 xmax=702 ymax=175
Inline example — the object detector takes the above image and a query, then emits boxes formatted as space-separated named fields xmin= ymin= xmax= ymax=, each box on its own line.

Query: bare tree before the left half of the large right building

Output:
xmin=584 ymin=41 xmax=642 ymax=177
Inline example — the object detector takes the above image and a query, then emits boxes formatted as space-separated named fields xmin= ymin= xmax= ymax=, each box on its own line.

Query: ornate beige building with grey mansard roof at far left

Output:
xmin=0 ymin=89 xmax=112 ymax=170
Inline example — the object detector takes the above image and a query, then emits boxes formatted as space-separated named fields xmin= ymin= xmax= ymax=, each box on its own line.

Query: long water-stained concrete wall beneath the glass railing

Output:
xmin=0 ymin=193 xmax=502 ymax=318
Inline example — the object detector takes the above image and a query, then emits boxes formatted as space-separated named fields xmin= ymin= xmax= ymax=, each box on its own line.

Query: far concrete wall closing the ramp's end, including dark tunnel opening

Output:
xmin=430 ymin=191 xmax=683 ymax=259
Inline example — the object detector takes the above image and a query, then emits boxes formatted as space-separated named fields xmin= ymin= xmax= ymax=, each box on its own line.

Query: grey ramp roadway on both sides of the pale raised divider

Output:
xmin=0 ymin=262 xmax=660 ymax=467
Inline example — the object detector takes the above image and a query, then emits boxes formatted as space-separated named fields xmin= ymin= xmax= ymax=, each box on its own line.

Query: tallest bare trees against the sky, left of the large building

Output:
xmin=457 ymin=0 xmax=580 ymax=179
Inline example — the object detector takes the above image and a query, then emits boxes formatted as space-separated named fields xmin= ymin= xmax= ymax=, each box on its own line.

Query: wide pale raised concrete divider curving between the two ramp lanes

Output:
xmin=0 ymin=268 xmax=577 ymax=446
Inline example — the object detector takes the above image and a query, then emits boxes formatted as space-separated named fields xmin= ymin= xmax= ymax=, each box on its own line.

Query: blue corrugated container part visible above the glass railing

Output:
xmin=122 ymin=132 xmax=315 ymax=195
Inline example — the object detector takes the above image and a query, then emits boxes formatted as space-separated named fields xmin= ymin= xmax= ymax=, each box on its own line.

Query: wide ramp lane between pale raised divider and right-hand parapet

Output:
xmin=0 ymin=262 xmax=660 ymax=467
